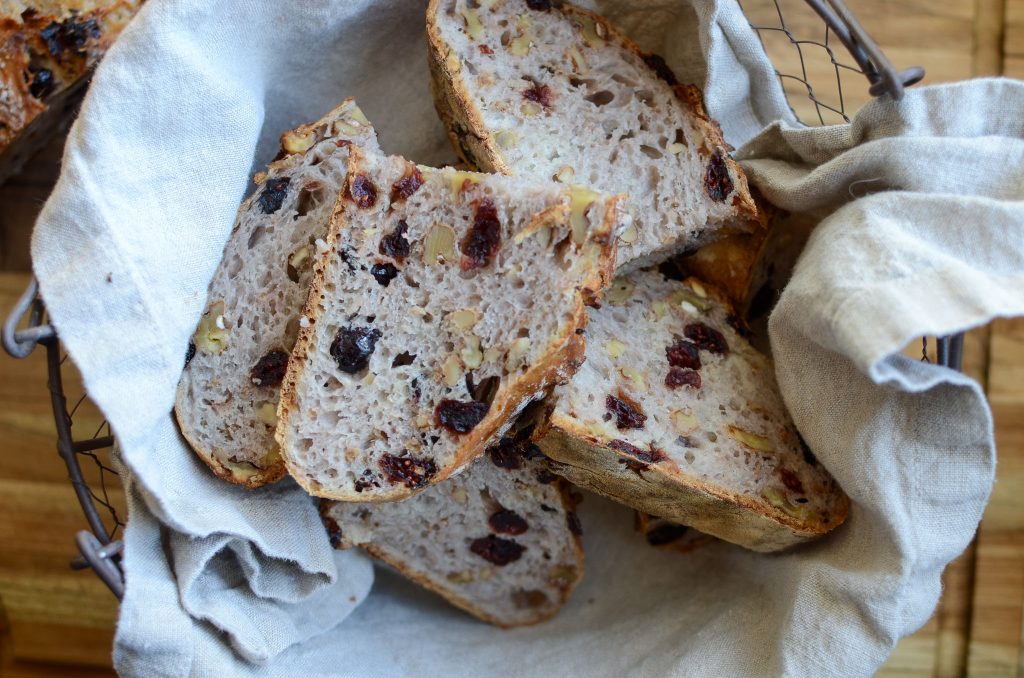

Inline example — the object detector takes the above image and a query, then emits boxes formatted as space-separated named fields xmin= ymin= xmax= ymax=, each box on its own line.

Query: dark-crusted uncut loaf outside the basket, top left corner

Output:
xmin=0 ymin=0 xmax=141 ymax=183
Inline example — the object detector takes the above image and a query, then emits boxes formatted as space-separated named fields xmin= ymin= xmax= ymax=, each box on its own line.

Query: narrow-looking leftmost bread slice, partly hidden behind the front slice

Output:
xmin=174 ymin=98 xmax=377 ymax=488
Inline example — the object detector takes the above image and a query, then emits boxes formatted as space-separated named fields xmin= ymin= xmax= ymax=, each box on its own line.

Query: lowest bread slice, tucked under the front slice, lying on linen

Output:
xmin=321 ymin=438 xmax=584 ymax=628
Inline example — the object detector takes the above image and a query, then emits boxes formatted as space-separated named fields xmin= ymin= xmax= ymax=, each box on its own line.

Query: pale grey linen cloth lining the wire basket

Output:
xmin=25 ymin=0 xmax=1024 ymax=676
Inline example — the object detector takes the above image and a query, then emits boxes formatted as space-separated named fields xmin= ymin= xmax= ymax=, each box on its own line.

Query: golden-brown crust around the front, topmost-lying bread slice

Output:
xmin=275 ymin=145 xmax=625 ymax=502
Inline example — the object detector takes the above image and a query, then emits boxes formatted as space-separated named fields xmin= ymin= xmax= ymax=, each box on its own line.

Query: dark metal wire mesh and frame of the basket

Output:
xmin=3 ymin=0 xmax=942 ymax=598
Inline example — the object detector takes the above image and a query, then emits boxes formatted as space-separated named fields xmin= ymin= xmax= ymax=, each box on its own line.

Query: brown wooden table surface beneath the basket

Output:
xmin=0 ymin=0 xmax=1024 ymax=677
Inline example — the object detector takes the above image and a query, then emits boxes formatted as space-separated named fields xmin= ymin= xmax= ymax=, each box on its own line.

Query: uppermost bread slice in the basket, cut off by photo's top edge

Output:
xmin=427 ymin=0 xmax=761 ymax=270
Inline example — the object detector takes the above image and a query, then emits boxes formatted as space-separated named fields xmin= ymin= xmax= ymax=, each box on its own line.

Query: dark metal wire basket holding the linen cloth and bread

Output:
xmin=3 ymin=0 xmax=950 ymax=599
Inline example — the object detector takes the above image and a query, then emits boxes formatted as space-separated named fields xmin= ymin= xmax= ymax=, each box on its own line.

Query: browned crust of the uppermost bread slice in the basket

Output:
xmin=427 ymin=0 xmax=764 ymax=235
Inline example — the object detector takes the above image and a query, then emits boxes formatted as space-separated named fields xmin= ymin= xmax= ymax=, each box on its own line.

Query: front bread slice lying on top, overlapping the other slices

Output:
xmin=278 ymin=147 xmax=625 ymax=502
